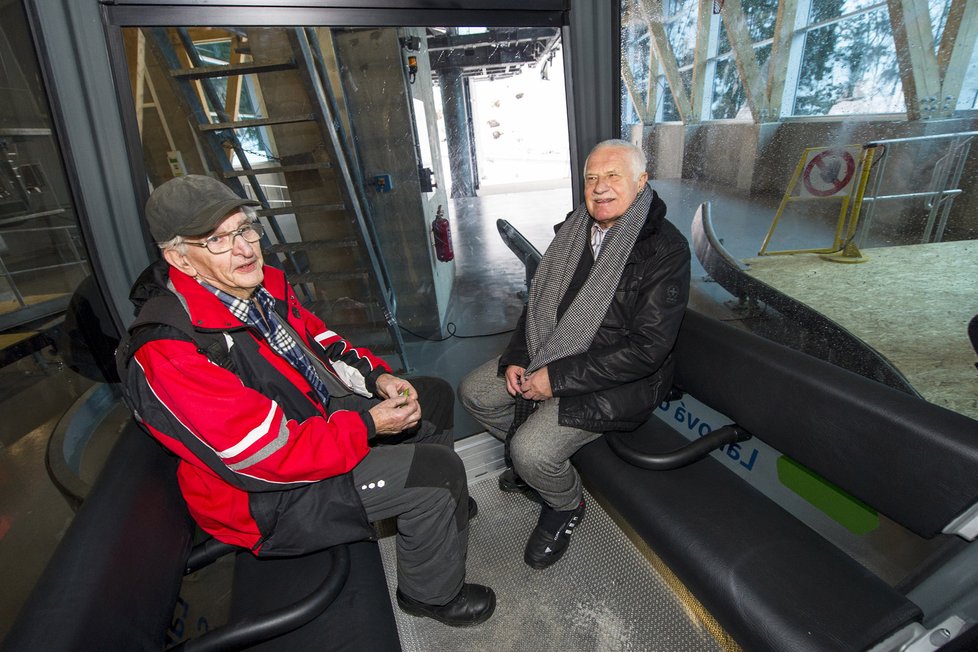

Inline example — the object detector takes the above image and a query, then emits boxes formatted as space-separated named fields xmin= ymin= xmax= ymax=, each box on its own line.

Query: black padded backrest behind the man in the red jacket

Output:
xmin=3 ymin=422 xmax=194 ymax=650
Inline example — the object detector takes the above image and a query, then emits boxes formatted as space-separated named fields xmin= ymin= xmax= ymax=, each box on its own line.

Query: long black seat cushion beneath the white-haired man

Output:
xmin=573 ymin=418 xmax=921 ymax=652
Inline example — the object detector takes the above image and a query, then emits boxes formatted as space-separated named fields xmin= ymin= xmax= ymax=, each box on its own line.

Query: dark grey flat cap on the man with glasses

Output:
xmin=146 ymin=174 xmax=261 ymax=242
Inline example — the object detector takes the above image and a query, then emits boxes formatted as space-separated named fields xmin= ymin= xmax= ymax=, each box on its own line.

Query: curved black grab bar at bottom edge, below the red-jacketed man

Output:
xmin=169 ymin=545 xmax=350 ymax=652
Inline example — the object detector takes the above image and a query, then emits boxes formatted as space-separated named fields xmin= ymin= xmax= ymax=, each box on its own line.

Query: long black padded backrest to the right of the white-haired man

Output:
xmin=676 ymin=310 xmax=978 ymax=538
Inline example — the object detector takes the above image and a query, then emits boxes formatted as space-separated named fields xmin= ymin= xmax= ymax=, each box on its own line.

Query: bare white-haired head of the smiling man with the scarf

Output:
xmin=584 ymin=147 xmax=649 ymax=228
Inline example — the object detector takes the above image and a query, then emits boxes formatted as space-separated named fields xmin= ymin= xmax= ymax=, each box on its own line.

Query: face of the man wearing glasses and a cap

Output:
xmin=163 ymin=211 xmax=265 ymax=299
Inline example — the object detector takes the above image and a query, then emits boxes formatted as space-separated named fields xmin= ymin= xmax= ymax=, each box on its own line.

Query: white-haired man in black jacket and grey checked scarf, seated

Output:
xmin=459 ymin=140 xmax=690 ymax=569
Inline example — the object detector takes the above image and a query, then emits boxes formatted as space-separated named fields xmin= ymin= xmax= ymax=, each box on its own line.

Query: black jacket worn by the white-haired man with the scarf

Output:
xmin=499 ymin=193 xmax=690 ymax=432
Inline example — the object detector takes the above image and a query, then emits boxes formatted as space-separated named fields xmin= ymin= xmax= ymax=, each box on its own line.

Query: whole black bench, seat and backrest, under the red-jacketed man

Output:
xmin=0 ymin=422 xmax=400 ymax=652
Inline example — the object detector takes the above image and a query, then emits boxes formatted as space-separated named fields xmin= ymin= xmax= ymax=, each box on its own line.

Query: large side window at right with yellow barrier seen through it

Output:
xmin=621 ymin=0 xmax=978 ymax=428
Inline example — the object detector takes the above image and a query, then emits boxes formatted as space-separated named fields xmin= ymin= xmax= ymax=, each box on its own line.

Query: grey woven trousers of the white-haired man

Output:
xmin=458 ymin=360 xmax=601 ymax=510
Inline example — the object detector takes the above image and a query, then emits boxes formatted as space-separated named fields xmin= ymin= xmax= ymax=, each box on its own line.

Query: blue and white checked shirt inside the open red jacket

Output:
xmin=200 ymin=281 xmax=329 ymax=405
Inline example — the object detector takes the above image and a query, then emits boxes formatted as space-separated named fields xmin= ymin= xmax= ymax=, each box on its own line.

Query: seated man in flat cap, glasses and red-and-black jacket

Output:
xmin=118 ymin=175 xmax=496 ymax=625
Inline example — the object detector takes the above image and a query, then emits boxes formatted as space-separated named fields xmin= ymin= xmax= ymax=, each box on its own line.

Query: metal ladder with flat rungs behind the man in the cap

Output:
xmin=145 ymin=28 xmax=410 ymax=371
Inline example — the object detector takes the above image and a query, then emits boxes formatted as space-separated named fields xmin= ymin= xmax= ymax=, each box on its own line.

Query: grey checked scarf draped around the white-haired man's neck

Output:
xmin=526 ymin=185 xmax=653 ymax=373
